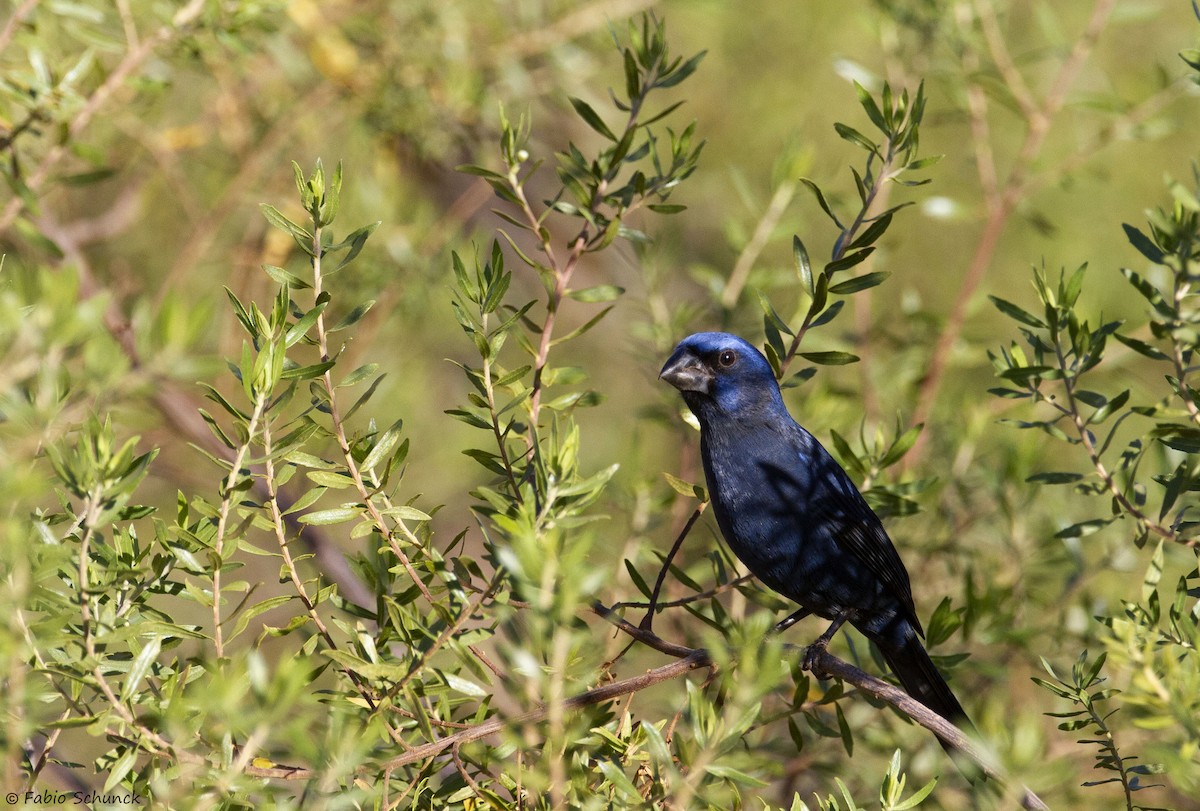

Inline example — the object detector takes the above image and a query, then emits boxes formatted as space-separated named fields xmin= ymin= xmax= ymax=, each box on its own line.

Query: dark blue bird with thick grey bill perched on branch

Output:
xmin=660 ymin=332 xmax=966 ymax=722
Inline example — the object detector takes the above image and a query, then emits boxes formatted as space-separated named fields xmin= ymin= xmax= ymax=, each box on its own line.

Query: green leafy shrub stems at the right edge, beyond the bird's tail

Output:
xmin=991 ymin=166 xmax=1200 ymax=809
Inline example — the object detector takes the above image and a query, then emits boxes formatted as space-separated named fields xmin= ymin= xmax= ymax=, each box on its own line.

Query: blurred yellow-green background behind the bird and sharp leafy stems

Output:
xmin=7 ymin=0 xmax=1200 ymax=807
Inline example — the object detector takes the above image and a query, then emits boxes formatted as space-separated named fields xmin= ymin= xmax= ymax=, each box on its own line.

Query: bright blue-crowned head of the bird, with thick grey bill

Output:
xmin=659 ymin=332 xmax=784 ymax=421
